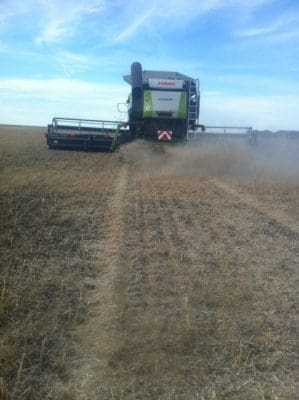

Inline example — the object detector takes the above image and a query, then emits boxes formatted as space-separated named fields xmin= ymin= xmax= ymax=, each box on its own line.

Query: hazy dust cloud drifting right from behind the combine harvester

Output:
xmin=121 ymin=138 xmax=299 ymax=183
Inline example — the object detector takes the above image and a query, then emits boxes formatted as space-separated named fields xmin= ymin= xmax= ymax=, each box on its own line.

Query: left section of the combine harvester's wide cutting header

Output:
xmin=46 ymin=118 xmax=131 ymax=151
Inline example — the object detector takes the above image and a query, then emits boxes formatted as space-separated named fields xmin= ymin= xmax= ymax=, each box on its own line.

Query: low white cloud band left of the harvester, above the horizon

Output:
xmin=0 ymin=79 xmax=129 ymax=126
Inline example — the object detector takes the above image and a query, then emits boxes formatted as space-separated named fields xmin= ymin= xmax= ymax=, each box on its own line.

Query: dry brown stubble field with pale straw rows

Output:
xmin=0 ymin=126 xmax=299 ymax=400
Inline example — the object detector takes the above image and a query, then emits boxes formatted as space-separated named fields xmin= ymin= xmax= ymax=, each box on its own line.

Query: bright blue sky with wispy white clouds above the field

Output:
xmin=0 ymin=0 xmax=299 ymax=130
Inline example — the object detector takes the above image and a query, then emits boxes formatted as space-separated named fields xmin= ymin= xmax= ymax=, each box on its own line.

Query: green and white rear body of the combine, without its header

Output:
xmin=124 ymin=62 xmax=202 ymax=141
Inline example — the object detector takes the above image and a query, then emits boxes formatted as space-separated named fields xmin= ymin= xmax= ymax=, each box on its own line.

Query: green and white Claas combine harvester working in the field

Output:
xmin=46 ymin=62 xmax=254 ymax=151
